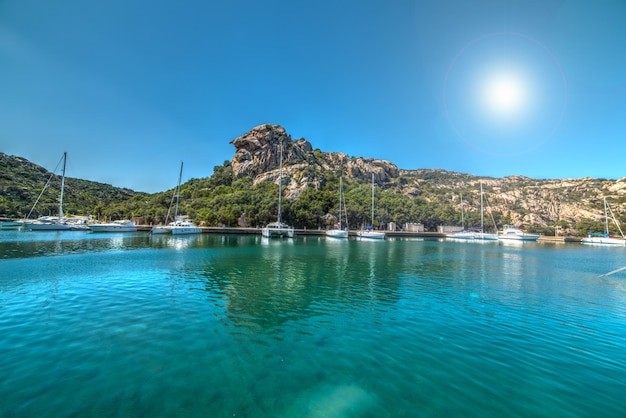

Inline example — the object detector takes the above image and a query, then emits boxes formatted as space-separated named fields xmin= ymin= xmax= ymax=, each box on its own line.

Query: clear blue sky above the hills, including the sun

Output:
xmin=0 ymin=0 xmax=626 ymax=192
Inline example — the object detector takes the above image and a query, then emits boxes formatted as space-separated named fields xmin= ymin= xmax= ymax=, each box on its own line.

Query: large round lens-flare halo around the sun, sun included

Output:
xmin=443 ymin=32 xmax=567 ymax=156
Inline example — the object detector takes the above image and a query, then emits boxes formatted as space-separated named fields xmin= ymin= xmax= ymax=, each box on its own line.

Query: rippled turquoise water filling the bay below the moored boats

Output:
xmin=0 ymin=231 xmax=626 ymax=417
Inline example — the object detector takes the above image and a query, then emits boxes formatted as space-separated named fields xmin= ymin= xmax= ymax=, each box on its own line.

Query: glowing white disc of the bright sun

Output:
xmin=484 ymin=74 xmax=527 ymax=117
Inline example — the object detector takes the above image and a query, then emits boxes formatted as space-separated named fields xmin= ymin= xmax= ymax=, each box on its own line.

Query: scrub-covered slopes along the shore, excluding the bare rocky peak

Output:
xmin=0 ymin=153 xmax=626 ymax=235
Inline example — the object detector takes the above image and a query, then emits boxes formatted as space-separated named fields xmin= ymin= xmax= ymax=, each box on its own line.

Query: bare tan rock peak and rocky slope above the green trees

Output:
xmin=231 ymin=124 xmax=626 ymax=233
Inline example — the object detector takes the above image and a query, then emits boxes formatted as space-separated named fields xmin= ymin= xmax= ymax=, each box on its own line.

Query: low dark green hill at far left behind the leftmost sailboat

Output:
xmin=0 ymin=153 xmax=143 ymax=218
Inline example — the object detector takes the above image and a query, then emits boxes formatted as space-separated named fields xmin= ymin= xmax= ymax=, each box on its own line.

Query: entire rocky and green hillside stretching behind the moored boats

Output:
xmin=0 ymin=124 xmax=626 ymax=235
